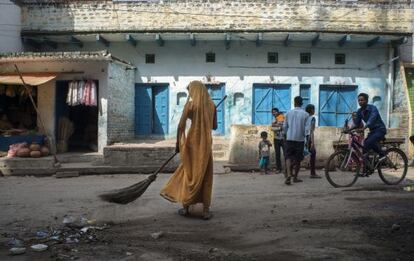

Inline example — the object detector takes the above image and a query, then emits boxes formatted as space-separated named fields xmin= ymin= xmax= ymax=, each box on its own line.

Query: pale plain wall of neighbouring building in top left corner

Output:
xmin=0 ymin=0 xmax=23 ymax=53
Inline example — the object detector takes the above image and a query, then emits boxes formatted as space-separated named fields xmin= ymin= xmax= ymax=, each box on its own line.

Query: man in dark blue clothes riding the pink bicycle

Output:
xmin=354 ymin=93 xmax=387 ymax=172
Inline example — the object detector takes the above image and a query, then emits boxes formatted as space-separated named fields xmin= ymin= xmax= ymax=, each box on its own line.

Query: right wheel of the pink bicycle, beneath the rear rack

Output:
xmin=377 ymin=148 xmax=408 ymax=185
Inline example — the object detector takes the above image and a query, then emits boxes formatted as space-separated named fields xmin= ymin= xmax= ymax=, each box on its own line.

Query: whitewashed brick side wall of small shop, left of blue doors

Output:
xmin=107 ymin=63 xmax=135 ymax=144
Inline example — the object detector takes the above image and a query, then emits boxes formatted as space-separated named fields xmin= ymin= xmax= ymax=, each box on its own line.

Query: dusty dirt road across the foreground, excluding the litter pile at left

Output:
xmin=0 ymin=169 xmax=414 ymax=261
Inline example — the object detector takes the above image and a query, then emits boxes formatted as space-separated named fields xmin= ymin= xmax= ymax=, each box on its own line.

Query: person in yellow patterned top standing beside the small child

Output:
xmin=272 ymin=108 xmax=285 ymax=174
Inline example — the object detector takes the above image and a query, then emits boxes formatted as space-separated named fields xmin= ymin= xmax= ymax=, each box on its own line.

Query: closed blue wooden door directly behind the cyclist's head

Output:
xmin=319 ymin=85 xmax=357 ymax=127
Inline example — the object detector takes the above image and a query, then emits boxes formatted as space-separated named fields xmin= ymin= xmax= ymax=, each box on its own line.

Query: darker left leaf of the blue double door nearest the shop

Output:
xmin=135 ymin=84 xmax=152 ymax=135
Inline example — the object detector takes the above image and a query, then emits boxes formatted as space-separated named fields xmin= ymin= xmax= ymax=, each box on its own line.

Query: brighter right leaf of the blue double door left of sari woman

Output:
xmin=152 ymin=86 xmax=169 ymax=135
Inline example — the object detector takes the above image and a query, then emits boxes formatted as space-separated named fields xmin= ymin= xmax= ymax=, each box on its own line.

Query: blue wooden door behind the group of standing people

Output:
xmin=252 ymin=84 xmax=291 ymax=125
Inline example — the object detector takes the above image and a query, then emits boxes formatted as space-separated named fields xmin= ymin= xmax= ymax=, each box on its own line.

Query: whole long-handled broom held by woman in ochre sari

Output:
xmin=99 ymin=95 xmax=227 ymax=205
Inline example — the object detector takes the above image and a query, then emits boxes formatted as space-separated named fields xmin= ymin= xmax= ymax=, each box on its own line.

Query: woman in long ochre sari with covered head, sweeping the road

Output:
xmin=161 ymin=81 xmax=217 ymax=219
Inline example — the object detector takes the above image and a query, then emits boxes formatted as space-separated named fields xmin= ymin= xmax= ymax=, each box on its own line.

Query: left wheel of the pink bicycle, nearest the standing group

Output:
xmin=325 ymin=151 xmax=361 ymax=188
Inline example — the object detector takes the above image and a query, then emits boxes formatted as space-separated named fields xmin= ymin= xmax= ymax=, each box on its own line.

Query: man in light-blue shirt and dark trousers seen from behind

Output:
xmin=283 ymin=96 xmax=309 ymax=185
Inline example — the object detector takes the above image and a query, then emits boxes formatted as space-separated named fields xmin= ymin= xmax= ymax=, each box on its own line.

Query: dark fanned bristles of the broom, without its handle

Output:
xmin=99 ymin=175 xmax=155 ymax=204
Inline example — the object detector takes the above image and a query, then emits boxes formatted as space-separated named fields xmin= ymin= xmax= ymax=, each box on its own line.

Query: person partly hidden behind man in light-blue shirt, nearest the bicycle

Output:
xmin=305 ymin=104 xmax=321 ymax=179
